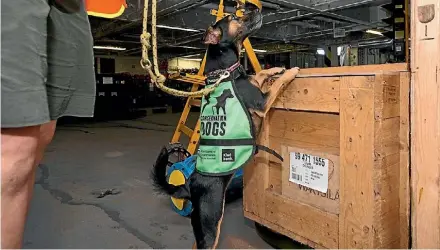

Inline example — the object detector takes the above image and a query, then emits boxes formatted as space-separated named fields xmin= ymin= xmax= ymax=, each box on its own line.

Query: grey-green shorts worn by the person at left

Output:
xmin=1 ymin=0 xmax=96 ymax=128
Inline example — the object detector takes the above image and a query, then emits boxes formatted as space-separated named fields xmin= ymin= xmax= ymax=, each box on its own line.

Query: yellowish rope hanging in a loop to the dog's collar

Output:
xmin=140 ymin=0 xmax=225 ymax=97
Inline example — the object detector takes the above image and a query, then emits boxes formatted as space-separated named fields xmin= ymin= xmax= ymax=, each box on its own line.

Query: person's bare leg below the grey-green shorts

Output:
xmin=1 ymin=126 xmax=40 ymax=249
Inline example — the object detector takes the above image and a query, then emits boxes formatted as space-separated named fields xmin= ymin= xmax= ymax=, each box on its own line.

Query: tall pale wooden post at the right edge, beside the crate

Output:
xmin=411 ymin=0 xmax=440 ymax=249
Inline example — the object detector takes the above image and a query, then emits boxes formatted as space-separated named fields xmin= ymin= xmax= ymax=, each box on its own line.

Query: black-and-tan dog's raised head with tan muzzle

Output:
xmin=203 ymin=9 xmax=263 ymax=53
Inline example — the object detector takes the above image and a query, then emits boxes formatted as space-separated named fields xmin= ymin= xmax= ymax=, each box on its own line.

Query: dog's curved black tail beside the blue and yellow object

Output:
xmin=150 ymin=147 xmax=190 ymax=199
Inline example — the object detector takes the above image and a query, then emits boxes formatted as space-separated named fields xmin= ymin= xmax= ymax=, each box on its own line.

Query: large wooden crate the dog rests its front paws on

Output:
xmin=243 ymin=64 xmax=409 ymax=248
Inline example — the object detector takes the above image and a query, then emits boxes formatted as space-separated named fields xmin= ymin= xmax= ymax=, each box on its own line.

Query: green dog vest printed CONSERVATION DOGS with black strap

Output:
xmin=196 ymin=64 xmax=283 ymax=176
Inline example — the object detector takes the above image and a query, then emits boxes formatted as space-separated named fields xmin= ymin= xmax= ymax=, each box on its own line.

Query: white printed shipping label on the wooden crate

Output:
xmin=289 ymin=152 xmax=329 ymax=193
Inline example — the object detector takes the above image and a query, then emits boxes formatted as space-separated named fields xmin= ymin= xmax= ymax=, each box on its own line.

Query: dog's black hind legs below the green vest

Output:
xmin=190 ymin=173 xmax=233 ymax=249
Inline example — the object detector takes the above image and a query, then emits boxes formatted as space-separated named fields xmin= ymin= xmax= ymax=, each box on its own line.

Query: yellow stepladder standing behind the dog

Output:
xmin=170 ymin=0 xmax=261 ymax=155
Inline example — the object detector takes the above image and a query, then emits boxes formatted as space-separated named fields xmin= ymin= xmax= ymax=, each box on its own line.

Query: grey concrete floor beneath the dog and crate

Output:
xmin=24 ymin=114 xmax=271 ymax=249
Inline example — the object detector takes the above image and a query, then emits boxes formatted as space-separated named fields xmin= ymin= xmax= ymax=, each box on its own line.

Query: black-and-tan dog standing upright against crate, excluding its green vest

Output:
xmin=152 ymin=6 xmax=298 ymax=249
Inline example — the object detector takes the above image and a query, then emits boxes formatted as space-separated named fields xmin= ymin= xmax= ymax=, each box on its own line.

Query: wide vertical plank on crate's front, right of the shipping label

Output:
xmin=339 ymin=77 xmax=374 ymax=248
